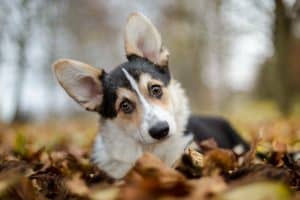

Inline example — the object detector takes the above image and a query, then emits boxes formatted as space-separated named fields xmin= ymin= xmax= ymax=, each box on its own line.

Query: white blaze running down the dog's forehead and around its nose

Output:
xmin=122 ymin=68 xmax=176 ymax=143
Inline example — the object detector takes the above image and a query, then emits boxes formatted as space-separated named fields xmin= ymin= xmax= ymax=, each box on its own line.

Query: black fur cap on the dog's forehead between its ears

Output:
xmin=99 ymin=56 xmax=170 ymax=118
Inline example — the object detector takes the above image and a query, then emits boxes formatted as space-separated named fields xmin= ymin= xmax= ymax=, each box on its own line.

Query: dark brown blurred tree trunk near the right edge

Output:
xmin=257 ymin=0 xmax=295 ymax=115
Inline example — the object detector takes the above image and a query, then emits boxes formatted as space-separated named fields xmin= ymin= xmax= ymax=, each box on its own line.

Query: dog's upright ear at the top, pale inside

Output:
xmin=125 ymin=13 xmax=169 ymax=67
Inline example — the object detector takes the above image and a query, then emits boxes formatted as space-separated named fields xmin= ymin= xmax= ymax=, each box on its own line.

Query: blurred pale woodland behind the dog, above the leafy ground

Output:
xmin=0 ymin=0 xmax=300 ymax=123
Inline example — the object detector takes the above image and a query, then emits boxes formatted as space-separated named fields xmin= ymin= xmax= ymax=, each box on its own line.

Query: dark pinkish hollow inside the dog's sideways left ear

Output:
xmin=79 ymin=76 xmax=101 ymax=98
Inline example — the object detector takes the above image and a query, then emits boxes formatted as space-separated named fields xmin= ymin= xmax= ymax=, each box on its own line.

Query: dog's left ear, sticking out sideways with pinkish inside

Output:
xmin=53 ymin=59 xmax=105 ymax=111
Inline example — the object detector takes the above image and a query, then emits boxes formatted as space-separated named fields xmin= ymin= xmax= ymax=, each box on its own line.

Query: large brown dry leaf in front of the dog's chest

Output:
xmin=119 ymin=153 xmax=191 ymax=200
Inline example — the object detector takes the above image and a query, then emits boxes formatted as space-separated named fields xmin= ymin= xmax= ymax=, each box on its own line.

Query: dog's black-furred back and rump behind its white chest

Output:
xmin=187 ymin=116 xmax=249 ymax=150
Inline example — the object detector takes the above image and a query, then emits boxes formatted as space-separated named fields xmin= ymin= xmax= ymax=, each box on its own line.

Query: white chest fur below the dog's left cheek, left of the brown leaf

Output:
xmin=92 ymin=120 xmax=143 ymax=179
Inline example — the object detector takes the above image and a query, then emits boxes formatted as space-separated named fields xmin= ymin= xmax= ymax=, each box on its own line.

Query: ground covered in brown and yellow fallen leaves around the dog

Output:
xmin=0 ymin=119 xmax=300 ymax=200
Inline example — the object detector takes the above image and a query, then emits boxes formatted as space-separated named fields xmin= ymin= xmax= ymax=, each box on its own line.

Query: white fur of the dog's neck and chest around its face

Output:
xmin=92 ymin=80 xmax=192 ymax=178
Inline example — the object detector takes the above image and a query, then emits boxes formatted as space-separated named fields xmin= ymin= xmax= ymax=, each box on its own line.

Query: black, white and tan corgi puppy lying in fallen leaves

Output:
xmin=53 ymin=13 xmax=248 ymax=179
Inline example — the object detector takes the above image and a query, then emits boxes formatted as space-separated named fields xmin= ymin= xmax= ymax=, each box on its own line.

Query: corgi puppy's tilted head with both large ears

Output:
xmin=54 ymin=13 xmax=187 ymax=144
